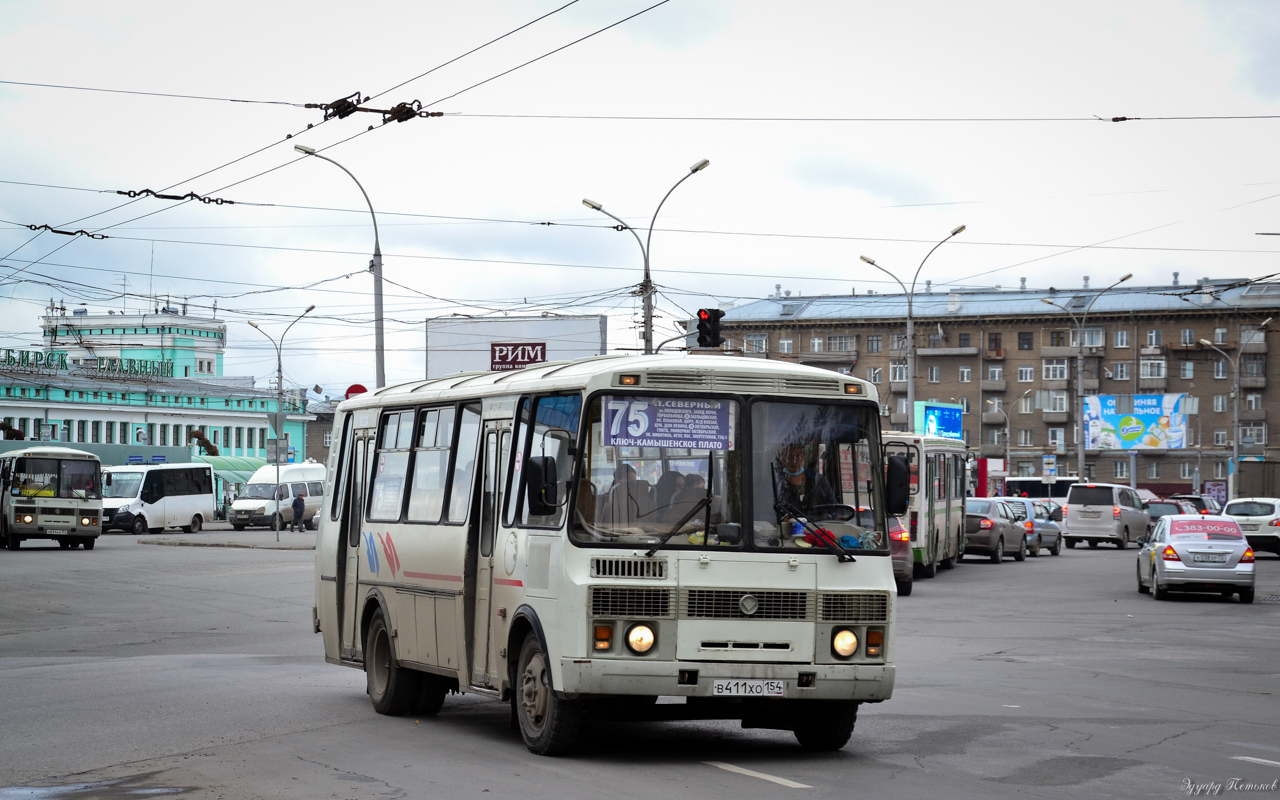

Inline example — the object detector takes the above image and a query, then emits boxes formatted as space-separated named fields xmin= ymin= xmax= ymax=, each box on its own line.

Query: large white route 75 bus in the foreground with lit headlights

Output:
xmin=314 ymin=356 xmax=908 ymax=754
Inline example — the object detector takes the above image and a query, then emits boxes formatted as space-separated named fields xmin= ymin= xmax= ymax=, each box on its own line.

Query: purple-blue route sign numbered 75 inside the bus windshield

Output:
xmin=604 ymin=397 xmax=733 ymax=451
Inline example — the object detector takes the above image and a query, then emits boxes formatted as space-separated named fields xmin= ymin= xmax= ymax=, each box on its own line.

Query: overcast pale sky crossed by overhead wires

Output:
xmin=0 ymin=0 xmax=1280 ymax=393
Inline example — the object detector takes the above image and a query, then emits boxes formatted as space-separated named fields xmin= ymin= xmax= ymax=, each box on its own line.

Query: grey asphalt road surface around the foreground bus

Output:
xmin=0 ymin=535 xmax=1280 ymax=800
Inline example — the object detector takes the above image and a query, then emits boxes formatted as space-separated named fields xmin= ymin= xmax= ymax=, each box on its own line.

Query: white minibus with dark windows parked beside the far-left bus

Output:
xmin=102 ymin=463 xmax=216 ymax=535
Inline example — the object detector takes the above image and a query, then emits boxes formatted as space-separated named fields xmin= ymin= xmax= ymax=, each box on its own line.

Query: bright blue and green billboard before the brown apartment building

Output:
xmin=1084 ymin=394 xmax=1187 ymax=451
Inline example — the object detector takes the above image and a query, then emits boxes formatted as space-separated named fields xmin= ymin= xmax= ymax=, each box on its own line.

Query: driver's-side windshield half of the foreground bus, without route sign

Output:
xmin=751 ymin=402 xmax=888 ymax=550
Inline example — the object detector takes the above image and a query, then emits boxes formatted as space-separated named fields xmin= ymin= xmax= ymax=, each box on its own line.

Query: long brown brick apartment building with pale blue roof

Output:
xmin=723 ymin=274 xmax=1280 ymax=494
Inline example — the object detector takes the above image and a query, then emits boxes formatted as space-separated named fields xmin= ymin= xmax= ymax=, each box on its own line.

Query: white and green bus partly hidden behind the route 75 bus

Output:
xmin=883 ymin=433 xmax=969 ymax=577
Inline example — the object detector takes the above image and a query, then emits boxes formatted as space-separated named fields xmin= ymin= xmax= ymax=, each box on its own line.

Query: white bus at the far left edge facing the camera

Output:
xmin=0 ymin=447 xmax=102 ymax=550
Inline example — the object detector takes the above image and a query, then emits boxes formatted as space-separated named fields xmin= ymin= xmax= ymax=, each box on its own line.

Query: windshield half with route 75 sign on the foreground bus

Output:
xmin=570 ymin=396 xmax=742 ymax=548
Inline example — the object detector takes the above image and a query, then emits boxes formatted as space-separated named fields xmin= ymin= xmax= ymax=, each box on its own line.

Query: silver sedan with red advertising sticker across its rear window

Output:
xmin=1138 ymin=515 xmax=1254 ymax=603
